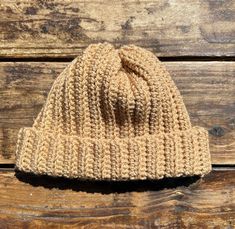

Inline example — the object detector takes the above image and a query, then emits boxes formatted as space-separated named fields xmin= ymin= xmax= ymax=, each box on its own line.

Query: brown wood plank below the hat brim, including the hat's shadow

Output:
xmin=0 ymin=171 xmax=235 ymax=229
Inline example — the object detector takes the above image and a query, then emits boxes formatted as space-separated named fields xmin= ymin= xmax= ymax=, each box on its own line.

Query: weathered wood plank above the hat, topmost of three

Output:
xmin=0 ymin=0 xmax=235 ymax=57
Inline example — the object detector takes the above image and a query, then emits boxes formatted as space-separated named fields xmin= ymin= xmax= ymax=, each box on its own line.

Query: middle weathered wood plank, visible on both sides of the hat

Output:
xmin=0 ymin=62 xmax=235 ymax=164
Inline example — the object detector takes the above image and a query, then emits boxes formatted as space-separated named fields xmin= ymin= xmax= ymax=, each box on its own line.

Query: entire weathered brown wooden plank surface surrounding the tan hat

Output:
xmin=0 ymin=0 xmax=235 ymax=229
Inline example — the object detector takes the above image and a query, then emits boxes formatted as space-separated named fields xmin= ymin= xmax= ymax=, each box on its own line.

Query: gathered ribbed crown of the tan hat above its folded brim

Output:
xmin=33 ymin=42 xmax=191 ymax=138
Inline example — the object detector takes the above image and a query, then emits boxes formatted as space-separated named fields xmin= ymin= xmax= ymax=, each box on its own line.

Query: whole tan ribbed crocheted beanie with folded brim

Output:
xmin=15 ymin=42 xmax=211 ymax=180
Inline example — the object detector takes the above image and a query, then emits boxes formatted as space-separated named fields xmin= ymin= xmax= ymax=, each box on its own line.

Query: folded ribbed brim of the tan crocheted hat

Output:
xmin=15 ymin=126 xmax=211 ymax=180
